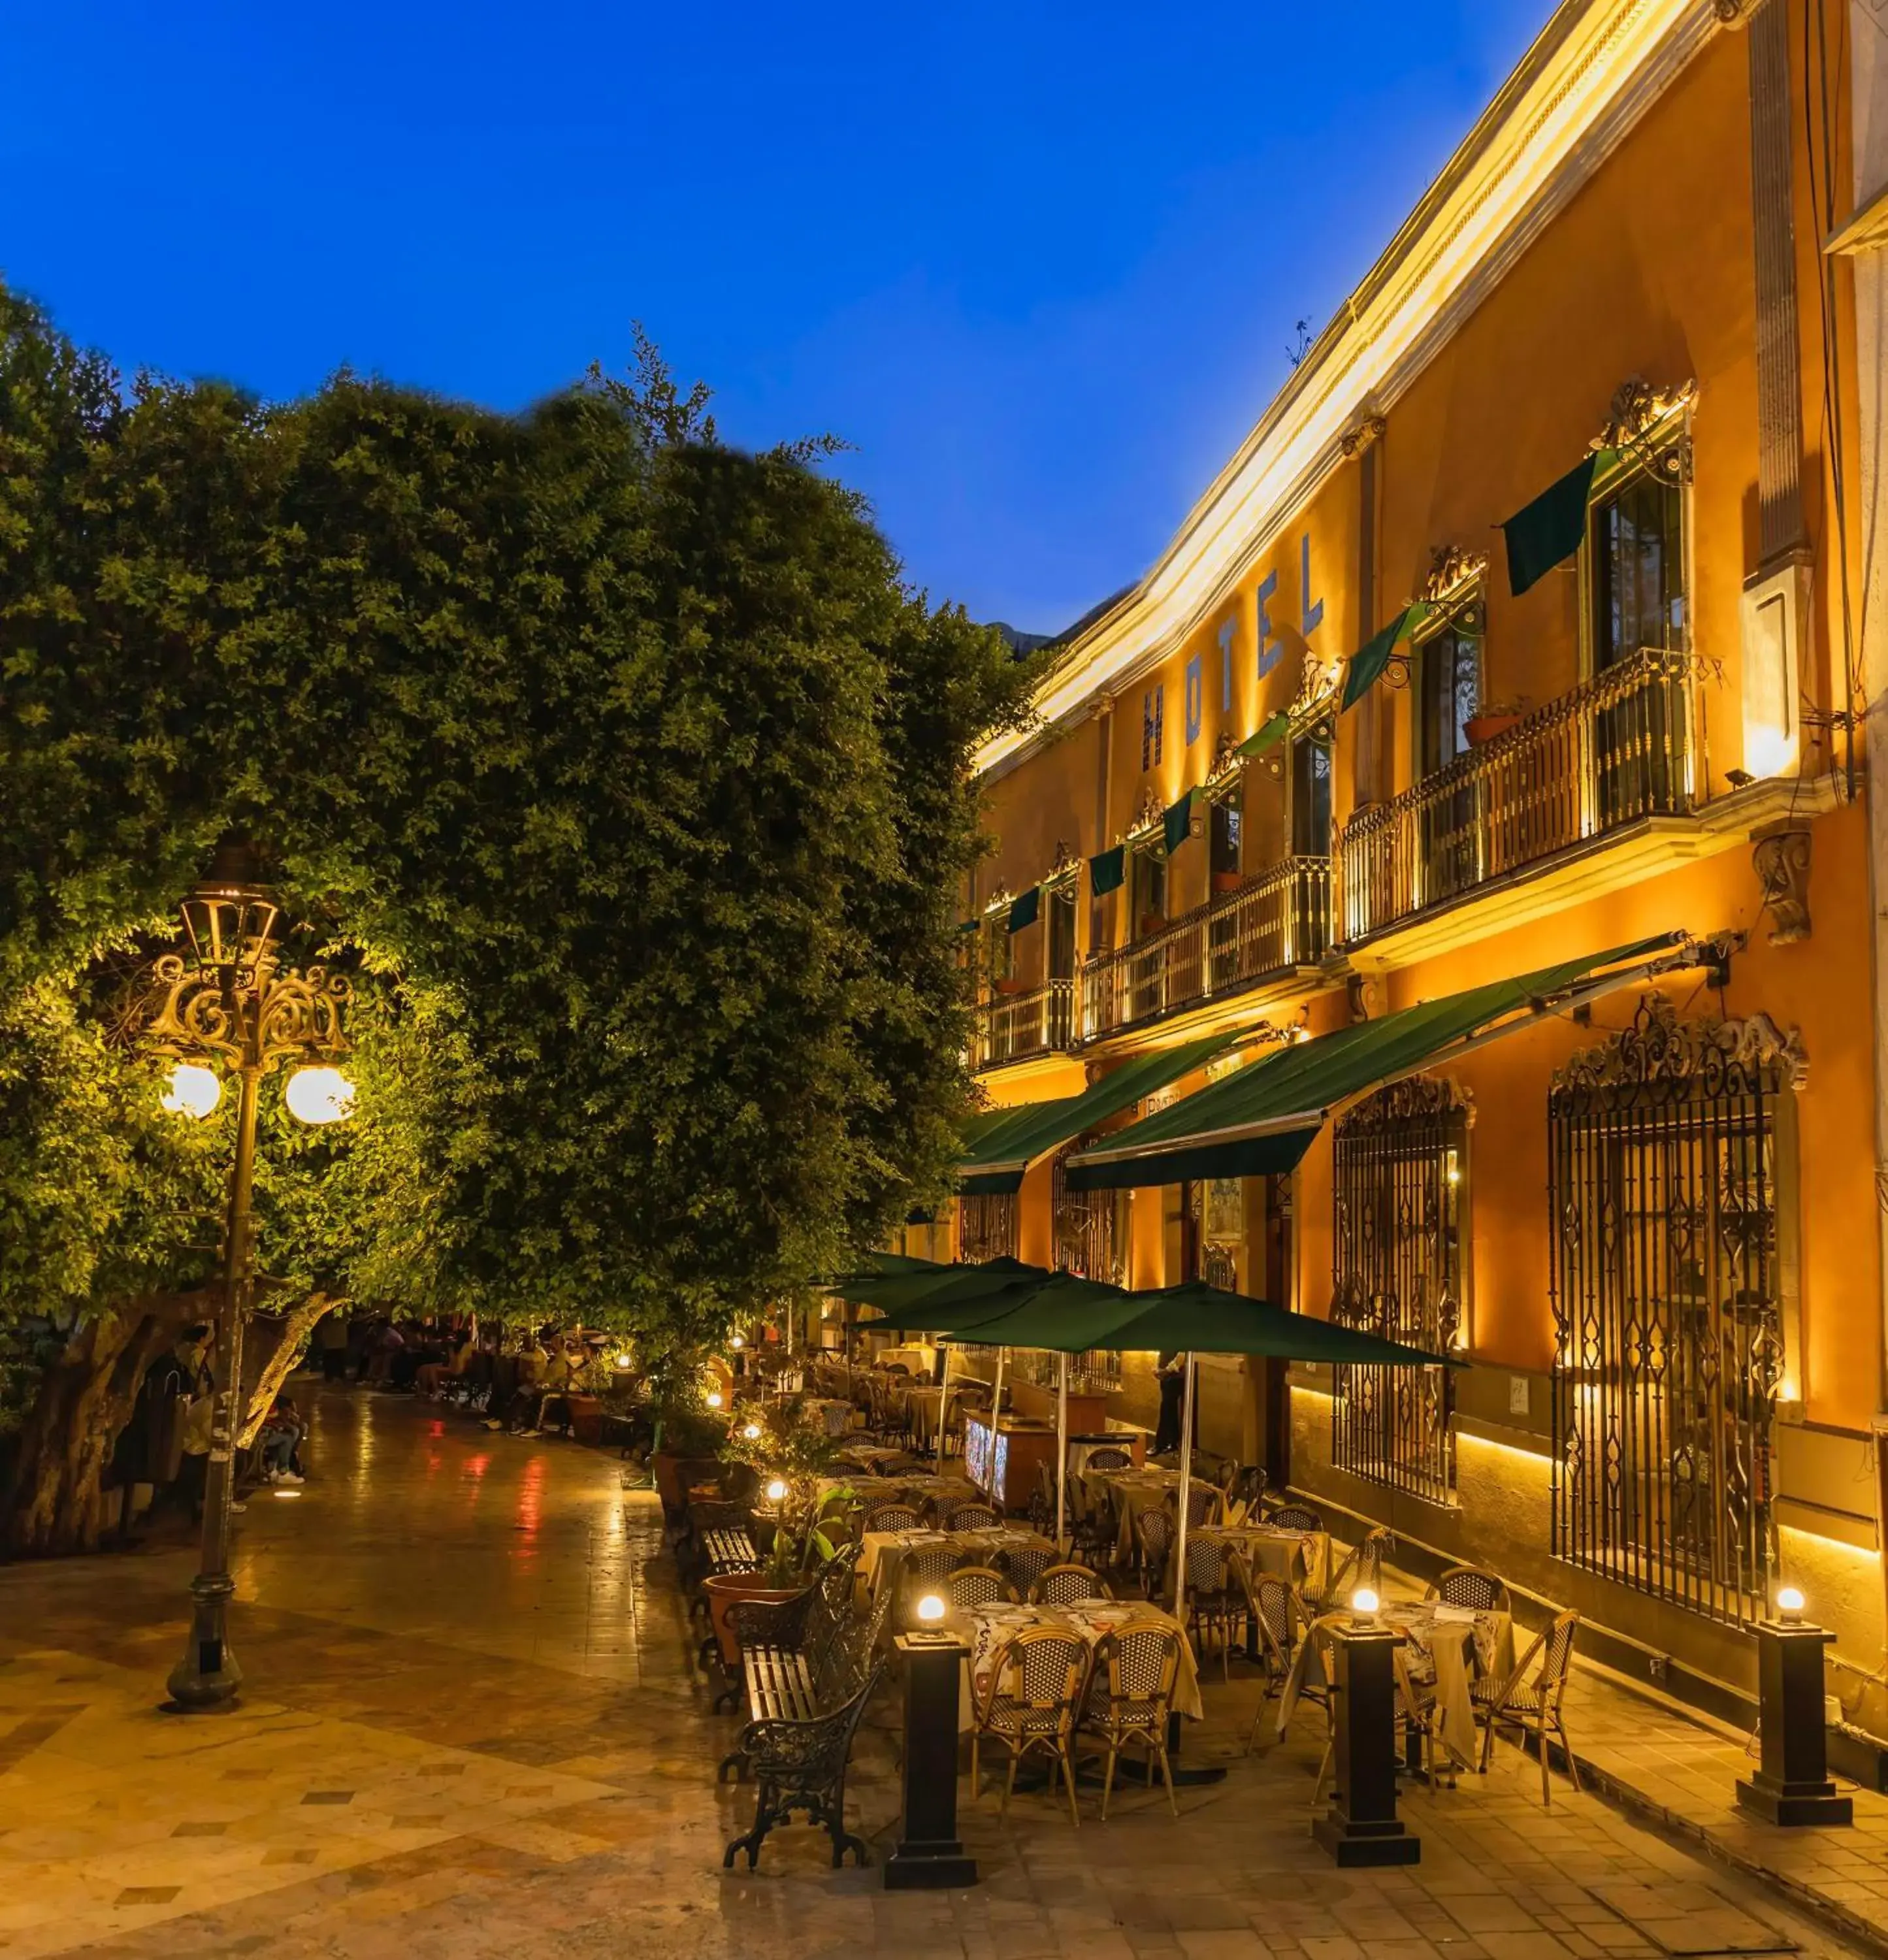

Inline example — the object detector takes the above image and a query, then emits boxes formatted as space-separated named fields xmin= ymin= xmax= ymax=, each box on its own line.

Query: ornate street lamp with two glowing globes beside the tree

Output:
xmin=143 ymin=841 xmax=353 ymax=1711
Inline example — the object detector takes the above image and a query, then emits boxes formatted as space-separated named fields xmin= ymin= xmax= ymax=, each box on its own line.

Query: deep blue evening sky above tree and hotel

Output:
xmin=0 ymin=0 xmax=1551 ymax=631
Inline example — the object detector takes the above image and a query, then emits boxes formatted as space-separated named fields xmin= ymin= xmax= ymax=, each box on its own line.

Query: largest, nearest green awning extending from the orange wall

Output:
xmin=1067 ymin=933 xmax=1708 ymax=1192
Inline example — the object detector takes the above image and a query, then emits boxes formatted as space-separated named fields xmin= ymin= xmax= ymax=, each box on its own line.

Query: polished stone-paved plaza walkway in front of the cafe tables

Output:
xmin=0 ymin=1392 xmax=1853 ymax=1960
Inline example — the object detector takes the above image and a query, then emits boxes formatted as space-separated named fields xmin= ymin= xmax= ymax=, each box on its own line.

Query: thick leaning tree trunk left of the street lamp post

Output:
xmin=0 ymin=1294 xmax=220 ymax=1556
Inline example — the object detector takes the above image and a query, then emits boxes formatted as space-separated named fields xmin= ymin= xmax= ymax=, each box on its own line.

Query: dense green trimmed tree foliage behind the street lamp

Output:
xmin=0 ymin=294 xmax=1030 ymax=1543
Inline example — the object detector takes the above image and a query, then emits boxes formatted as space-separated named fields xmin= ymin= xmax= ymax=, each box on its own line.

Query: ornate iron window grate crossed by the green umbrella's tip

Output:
xmin=1331 ymin=1076 xmax=1471 ymax=1503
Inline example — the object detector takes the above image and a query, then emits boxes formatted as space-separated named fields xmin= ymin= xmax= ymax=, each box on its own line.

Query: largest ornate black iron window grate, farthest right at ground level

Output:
xmin=1547 ymin=994 xmax=1802 ymax=1625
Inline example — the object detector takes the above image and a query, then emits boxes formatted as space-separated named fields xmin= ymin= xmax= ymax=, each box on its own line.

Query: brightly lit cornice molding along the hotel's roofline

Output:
xmin=977 ymin=0 xmax=1723 ymax=776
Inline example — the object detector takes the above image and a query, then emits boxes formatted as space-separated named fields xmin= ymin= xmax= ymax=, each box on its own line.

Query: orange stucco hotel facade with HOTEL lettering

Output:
xmin=909 ymin=0 xmax=1884 ymax=1701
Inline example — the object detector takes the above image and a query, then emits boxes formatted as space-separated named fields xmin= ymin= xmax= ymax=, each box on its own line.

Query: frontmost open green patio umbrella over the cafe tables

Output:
xmin=953 ymin=1282 xmax=1467 ymax=1368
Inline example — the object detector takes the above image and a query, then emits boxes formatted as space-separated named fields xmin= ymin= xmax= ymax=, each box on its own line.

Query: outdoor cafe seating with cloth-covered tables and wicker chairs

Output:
xmin=662 ymin=1254 xmax=1576 ymax=1866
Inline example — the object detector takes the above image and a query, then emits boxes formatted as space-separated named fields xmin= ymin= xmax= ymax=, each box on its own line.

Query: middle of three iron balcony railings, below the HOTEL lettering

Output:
xmin=1082 ymin=858 xmax=1331 ymax=1041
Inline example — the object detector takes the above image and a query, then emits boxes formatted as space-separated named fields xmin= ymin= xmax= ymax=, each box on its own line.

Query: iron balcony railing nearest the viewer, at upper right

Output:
xmin=1337 ymin=649 xmax=1698 ymax=943
